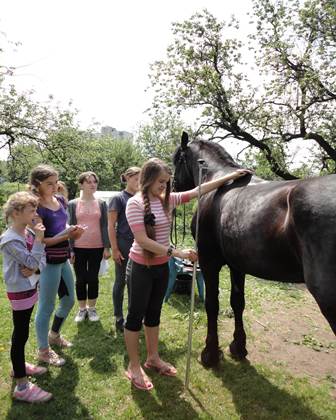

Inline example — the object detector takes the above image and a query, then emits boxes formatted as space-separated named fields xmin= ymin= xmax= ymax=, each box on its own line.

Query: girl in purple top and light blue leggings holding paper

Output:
xmin=30 ymin=165 xmax=83 ymax=366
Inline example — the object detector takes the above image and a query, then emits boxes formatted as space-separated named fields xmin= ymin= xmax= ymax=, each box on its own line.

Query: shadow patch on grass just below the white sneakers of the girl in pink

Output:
xmin=71 ymin=321 xmax=118 ymax=374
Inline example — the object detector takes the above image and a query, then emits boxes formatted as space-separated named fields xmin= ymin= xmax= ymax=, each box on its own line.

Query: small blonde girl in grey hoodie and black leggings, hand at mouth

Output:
xmin=0 ymin=191 xmax=52 ymax=402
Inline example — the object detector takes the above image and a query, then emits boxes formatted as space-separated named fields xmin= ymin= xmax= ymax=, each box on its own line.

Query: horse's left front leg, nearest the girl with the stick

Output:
xmin=200 ymin=260 xmax=221 ymax=367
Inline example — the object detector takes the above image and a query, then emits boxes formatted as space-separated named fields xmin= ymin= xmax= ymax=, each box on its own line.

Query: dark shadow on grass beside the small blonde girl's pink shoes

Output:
xmin=6 ymin=356 xmax=93 ymax=420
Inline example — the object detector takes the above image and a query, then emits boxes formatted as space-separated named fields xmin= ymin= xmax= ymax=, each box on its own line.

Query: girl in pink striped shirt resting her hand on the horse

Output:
xmin=125 ymin=158 xmax=246 ymax=391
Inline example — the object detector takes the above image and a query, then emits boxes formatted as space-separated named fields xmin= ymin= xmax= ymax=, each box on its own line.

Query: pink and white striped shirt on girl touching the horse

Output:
xmin=126 ymin=192 xmax=190 ymax=265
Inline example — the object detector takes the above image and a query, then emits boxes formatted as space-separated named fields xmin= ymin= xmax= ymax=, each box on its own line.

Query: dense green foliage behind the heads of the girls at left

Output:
xmin=7 ymin=128 xmax=143 ymax=197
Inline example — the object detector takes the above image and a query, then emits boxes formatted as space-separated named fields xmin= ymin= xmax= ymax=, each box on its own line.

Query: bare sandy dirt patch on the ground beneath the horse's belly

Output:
xmin=242 ymin=286 xmax=336 ymax=397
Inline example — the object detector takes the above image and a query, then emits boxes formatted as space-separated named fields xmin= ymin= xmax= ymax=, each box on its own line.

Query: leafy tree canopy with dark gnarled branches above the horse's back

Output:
xmin=151 ymin=0 xmax=336 ymax=179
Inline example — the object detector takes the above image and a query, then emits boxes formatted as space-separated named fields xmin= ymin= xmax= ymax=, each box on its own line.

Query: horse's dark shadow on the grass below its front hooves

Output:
xmin=213 ymin=359 xmax=321 ymax=420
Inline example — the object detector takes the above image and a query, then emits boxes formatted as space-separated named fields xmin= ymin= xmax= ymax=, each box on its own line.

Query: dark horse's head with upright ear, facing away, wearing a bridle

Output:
xmin=173 ymin=131 xmax=196 ymax=191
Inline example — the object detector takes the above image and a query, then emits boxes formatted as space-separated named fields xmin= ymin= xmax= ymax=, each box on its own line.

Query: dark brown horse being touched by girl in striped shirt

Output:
xmin=174 ymin=133 xmax=336 ymax=366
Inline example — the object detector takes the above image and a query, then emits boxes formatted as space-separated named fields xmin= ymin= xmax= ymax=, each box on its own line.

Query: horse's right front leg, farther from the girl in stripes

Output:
xmin=230 ymin=268 xmax=247 ymax=360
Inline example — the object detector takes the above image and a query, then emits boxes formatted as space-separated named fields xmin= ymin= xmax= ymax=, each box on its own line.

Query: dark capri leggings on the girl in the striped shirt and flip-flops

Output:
xmin=125 ymin=259 xmax=169 ymax=331
